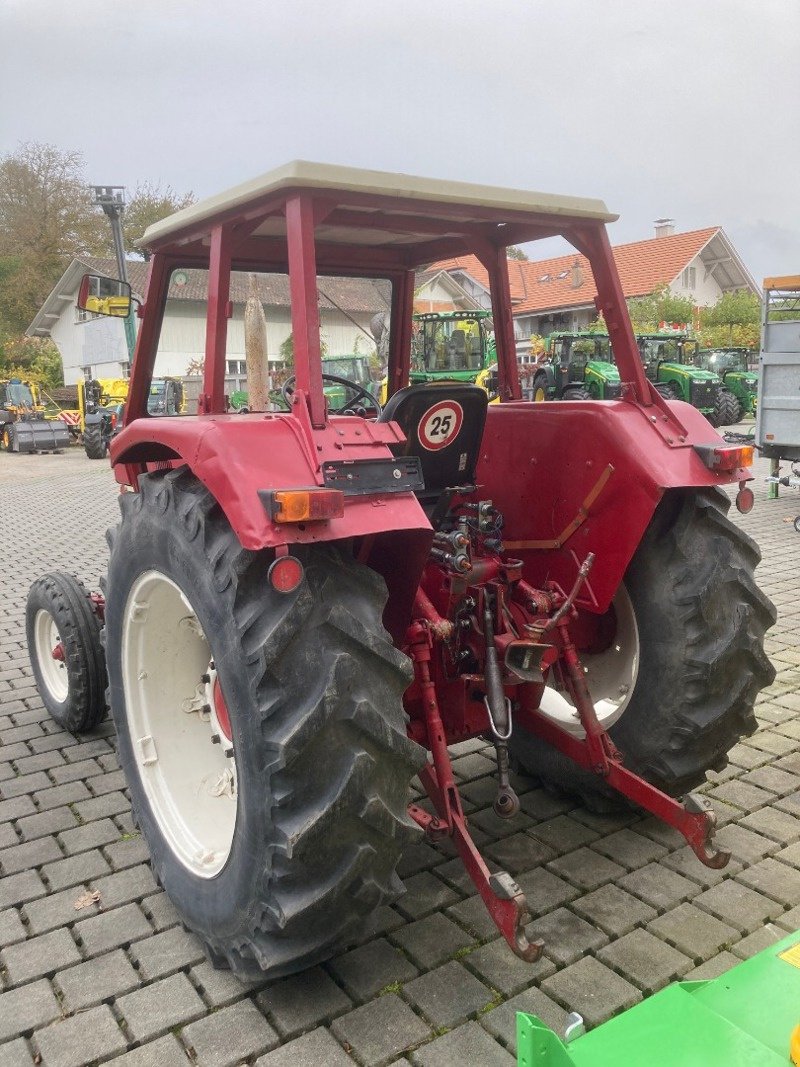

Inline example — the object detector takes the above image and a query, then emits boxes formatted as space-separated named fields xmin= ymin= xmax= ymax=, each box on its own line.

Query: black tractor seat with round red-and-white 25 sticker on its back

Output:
xmin=379 ymin=382 xmax=489 ymax=505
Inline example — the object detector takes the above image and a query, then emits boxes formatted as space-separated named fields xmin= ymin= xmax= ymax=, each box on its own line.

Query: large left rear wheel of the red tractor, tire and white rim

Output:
xmin=106 ymin=469 xmax=425 ymax=977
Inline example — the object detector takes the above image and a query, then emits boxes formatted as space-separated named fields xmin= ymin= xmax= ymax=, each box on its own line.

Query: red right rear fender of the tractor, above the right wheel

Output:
xmin=478 ymin=400 xmax=752 ymax=611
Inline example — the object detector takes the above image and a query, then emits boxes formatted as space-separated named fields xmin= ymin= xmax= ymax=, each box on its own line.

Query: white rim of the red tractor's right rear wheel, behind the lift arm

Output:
xmin=540 ymin=586 xmax=639 ymax=737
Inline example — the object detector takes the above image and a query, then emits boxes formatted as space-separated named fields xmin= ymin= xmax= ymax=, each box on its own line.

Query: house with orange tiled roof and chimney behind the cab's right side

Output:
xmin=426 ymin=220 xmax=758 ymax=352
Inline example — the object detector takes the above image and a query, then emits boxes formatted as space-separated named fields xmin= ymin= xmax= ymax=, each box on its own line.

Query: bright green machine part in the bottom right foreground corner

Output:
xmin=516 ymin=931 xmax=800 ymax=1067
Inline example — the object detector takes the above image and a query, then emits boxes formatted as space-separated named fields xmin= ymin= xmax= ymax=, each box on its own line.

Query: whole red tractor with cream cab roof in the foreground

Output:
xmin=28 ymin=163 xmax=774 ymax=976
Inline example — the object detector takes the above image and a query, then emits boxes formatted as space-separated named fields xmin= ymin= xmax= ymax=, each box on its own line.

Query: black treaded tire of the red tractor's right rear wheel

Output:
xmin=511 ymin=489 xmax=775 ymax=810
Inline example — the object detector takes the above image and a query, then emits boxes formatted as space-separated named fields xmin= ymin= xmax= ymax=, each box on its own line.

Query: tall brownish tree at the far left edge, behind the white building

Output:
xmin=0 ymin=143 xmax=109 ymax=335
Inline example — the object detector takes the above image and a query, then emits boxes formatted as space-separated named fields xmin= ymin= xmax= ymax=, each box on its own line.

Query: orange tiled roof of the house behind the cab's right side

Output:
xmin=429 ymin=226 xmax=720 ymax=315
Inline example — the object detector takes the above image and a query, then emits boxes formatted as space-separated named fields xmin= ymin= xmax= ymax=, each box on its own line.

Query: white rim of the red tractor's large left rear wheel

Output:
xmin=122 ymin=571 xmax=237 ymax=878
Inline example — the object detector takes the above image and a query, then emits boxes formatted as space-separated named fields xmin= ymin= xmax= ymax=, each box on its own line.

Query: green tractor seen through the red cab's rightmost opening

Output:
xmin=530 ymin=331 xmax=622 ymax=400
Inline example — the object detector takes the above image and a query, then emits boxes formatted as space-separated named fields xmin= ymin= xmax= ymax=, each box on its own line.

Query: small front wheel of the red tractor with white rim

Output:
xmin=26 ymin=571 xmax=107 ymax=733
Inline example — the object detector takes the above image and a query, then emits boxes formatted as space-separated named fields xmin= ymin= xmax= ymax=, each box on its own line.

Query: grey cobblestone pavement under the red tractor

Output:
xmin=0 ymin=437 xmax=800 ymax=1067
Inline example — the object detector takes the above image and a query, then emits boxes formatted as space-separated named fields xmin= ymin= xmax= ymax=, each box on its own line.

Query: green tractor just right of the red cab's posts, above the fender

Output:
xmin=636 ymin=331 xmax=730 ymax=426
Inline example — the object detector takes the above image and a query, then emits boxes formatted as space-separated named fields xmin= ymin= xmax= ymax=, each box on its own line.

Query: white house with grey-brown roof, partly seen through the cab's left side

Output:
xmin=26 ymin=256 xmax=392 ymax=388
